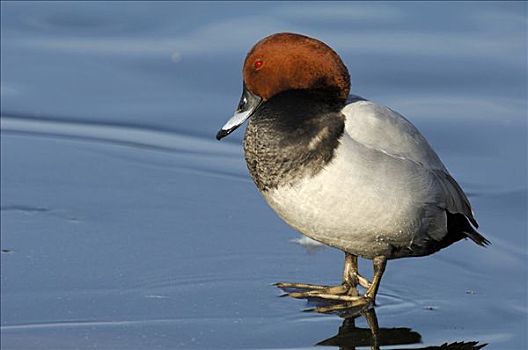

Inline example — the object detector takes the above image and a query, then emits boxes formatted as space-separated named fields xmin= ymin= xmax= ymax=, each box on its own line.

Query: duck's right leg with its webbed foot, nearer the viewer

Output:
xmin=313 ymin=256 xmax=387 ymax=312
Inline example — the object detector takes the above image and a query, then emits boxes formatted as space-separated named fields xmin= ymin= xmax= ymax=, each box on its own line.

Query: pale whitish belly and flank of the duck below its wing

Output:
xmin=263 ymin=140 xmax=422 ymax=258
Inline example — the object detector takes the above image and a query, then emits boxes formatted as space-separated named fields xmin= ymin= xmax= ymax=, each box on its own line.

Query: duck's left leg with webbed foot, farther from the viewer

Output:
xmin=275 ymin=253 xmax=369 ymax=298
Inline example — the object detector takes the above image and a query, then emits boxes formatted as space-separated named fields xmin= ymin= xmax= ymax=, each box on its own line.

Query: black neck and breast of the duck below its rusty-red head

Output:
xmin=244 ymin=90 xmax=346 ymax=192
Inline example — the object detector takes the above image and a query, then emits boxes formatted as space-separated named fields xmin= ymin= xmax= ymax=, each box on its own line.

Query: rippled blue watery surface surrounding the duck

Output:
xmin=0 ymin=1 xmax=528 ymax=350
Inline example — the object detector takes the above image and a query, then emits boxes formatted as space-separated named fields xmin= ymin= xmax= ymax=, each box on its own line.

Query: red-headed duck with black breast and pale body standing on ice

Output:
xmin=216 ymin=33 xmax=490 ymax=312
